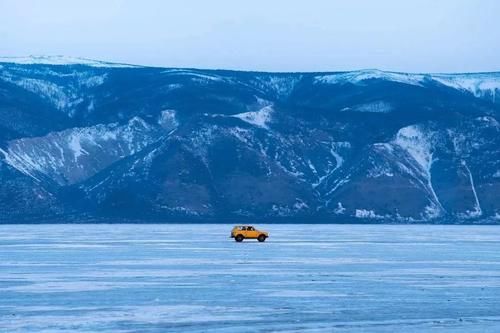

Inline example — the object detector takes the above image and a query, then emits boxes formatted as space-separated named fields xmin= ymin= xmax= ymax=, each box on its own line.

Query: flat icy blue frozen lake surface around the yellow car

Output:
xmin=0 ymin=225 xmax=500 ymax=333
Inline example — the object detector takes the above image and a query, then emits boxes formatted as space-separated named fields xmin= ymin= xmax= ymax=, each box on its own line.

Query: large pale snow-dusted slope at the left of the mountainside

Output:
xmin=0 ymin=118 xmax=161 ymax=185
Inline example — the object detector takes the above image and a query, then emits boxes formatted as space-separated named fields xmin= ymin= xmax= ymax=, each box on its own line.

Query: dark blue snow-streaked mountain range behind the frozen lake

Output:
xmin=0 ymin=57 xmax=500 ymax=223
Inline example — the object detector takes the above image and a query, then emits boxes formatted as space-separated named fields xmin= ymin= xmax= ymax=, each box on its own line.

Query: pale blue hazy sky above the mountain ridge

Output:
xmin=0 ymin=0 xmax=500 ymax=72
